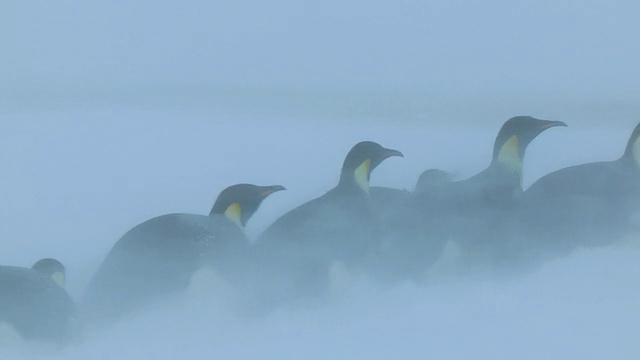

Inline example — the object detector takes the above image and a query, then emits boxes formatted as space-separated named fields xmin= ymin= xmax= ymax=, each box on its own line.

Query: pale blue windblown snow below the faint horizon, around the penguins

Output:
xmin=0 ymin=109 xmax=640 ymax=359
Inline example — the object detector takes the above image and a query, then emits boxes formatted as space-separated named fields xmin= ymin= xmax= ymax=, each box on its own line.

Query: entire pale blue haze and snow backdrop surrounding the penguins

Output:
xmin=0 ymin=0 xmax=640 ymax=359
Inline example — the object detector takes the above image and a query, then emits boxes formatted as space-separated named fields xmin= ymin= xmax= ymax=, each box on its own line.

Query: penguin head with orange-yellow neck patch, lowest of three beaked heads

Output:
xmin=209 ymin=184 xmax=286 ymax=229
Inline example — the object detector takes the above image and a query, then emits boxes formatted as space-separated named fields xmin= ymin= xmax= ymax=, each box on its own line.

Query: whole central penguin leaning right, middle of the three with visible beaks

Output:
xmin=255 ymin=141 xmax=402 ymax=303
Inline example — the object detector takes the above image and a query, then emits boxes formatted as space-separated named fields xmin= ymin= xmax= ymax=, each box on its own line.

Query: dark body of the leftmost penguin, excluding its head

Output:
xmin=0 ymin=258 xmax=77 ymax=343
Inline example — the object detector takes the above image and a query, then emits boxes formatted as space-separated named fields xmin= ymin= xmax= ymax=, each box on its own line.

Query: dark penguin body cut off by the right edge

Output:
xmin=519 ymin=125 xmax=640 ymax=258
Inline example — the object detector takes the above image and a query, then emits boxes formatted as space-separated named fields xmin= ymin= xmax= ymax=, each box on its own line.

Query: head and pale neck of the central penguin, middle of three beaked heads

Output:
xmin=338 ymin=141 xmax=404 ymax=194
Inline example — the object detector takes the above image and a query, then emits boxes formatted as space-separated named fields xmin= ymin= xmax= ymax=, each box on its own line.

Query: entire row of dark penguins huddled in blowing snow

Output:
xmin=5 ymin=116 xmax=640 ymax=342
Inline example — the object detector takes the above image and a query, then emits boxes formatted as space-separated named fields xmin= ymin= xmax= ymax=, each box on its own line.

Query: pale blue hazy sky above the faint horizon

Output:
xmin=0 ymin=0 xmax=640 ymax=111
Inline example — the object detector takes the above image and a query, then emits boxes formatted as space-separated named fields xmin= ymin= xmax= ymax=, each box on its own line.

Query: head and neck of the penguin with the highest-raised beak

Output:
xmin=493 ymin=116 xmax=567 ymax=174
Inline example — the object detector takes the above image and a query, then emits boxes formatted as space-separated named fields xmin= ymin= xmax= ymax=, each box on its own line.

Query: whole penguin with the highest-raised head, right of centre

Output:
xmin=383 ymin=116 xmax=566 ymax=280
